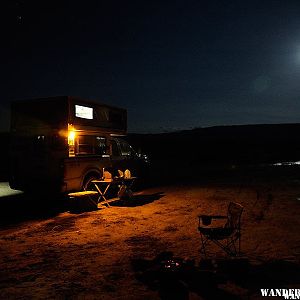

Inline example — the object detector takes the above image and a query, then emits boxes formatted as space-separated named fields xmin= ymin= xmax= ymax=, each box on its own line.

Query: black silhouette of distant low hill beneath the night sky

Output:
xmin=128 ymin=123 xmax=300 ymax=164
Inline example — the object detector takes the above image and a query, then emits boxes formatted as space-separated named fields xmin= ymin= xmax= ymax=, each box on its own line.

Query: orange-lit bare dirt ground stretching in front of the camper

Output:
xmin=0 ymin=182 xmax=300 ymax=299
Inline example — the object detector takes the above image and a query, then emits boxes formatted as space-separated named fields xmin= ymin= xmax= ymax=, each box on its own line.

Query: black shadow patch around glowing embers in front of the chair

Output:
xmin=132 ymin=252 xmax=300 ymax=299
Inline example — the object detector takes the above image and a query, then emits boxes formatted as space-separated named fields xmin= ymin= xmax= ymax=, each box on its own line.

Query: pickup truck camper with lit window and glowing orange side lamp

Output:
xmin=9 ymin=96 xmax=147 ymax=193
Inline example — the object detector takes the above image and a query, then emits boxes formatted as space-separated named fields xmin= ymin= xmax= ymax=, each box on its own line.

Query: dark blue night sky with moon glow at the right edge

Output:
xmin=0 ymin=0 xmax=300 ymax=132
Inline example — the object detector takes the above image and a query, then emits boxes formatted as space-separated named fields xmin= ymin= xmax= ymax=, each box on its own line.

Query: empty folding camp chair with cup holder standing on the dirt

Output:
xmin=198 ymin=202 xmax=243 ymax=257
